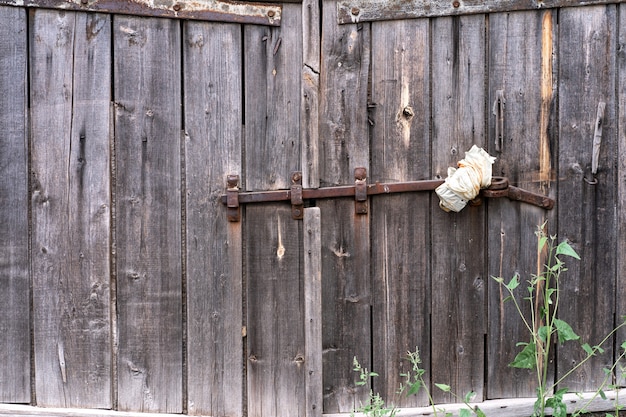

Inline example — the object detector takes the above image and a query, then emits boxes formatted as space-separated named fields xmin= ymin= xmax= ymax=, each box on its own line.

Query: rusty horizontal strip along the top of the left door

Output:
xmin=0 ymin=0 xmax=282 ymax=26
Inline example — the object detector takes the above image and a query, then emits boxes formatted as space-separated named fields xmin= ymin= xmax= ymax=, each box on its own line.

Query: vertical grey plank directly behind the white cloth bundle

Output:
xmin=431 ymin=15 xmax=487 ymax=402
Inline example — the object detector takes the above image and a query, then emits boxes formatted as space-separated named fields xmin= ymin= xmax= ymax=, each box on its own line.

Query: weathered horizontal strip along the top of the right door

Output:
xmin=337 ymin=0 xmax=624 ymax=23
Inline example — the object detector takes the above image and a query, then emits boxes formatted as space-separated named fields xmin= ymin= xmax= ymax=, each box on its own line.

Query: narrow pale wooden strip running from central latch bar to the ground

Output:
xmin=303 ymin=207 xmax=324 ymax=417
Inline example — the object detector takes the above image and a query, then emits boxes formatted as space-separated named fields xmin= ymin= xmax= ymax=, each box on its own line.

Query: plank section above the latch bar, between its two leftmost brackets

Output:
xmin=244 ymin=4 xmax=303 ymax=191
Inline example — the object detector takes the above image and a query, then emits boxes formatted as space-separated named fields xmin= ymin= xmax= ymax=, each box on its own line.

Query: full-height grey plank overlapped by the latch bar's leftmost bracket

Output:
xmin=183 ymin=22 xmax=243 ymax=416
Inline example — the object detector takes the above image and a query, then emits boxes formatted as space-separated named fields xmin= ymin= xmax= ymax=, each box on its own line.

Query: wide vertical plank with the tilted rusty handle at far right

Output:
xmin=556 ymin=5 xmax=618 ymax=391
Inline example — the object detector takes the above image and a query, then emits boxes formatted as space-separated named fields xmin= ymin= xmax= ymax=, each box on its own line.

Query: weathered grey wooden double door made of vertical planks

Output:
xmin=0 ymin=0 xmax=626 ymax=417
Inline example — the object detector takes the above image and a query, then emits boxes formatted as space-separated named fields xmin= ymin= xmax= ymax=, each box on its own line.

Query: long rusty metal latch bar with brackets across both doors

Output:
xmin=221 ymin=168 xmax=555 ymax=222
